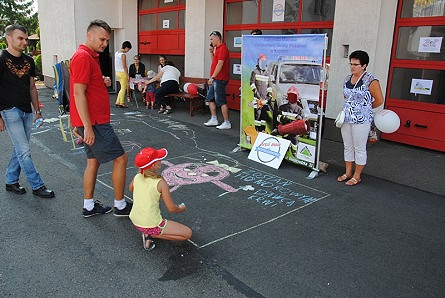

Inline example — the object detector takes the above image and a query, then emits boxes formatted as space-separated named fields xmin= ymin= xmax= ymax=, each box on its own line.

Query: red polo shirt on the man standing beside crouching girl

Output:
xmin=70 ymin=45 xmax=110 ymax=126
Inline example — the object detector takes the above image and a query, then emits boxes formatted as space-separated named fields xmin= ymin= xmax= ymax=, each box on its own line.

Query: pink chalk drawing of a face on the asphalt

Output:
xmin=162 ymin=160 xmax=238 ymax=192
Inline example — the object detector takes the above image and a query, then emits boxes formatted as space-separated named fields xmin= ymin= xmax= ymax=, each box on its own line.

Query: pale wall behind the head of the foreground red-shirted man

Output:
xmin=38 ymin=0 xmax=138 ymax=82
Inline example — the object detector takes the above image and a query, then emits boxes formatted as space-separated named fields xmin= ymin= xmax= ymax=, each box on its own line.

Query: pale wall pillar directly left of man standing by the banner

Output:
xmin=185 ymin=0 xmax=224 ymax=78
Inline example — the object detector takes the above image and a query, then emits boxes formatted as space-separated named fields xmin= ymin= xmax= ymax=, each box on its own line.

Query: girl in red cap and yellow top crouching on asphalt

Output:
xmin=129 ymin=147 xmax=192 ymax=250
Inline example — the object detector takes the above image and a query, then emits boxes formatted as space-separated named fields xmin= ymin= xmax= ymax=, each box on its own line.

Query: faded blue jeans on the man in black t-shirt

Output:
xmin=1 ymin=107 xmax=44 ymax=190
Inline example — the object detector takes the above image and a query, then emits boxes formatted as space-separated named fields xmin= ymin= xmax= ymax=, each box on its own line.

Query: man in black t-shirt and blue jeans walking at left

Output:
xmin=0 ymin=25 xmax=55 ymax=199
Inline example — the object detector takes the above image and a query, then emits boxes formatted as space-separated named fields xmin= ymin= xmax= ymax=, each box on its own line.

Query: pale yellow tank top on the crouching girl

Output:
xmin=130 ymin=174 xmax=162 ymax=228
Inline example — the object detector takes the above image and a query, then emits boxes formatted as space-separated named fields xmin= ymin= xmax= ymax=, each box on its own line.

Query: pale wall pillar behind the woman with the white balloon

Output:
xmin=326 ymin=0 xmax=397 ymax=118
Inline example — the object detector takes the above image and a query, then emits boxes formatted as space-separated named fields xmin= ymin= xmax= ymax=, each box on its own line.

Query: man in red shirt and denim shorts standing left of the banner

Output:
xmin=204 ymin=31 xmax=232 ymax=129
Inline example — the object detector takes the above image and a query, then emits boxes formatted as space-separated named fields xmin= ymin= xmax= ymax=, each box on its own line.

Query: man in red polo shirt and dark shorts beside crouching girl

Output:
xmin=70 ymin=20 xmax=133 ymax=217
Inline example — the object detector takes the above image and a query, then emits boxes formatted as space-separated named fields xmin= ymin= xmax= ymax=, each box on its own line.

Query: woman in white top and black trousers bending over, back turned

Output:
xmin=147 ymin=61 xmax=181 ymax=115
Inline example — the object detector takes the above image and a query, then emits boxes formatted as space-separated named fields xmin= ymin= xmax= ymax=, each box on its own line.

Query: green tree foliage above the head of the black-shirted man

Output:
xmin=0 ymin=0 xmax=39 ymax=36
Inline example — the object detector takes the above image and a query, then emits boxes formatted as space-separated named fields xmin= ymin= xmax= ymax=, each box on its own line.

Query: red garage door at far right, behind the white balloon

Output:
xmin=382 ymin=0 xmax=445 ymax=151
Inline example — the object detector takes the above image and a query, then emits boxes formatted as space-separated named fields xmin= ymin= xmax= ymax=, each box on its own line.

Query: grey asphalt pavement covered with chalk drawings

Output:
xmin=0 ymin=88 xmax=445 ymax=297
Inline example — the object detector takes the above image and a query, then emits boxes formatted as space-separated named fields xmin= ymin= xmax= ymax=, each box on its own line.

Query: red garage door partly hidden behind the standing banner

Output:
xmin=224 ymin=0 xmax=336 ymax=110
